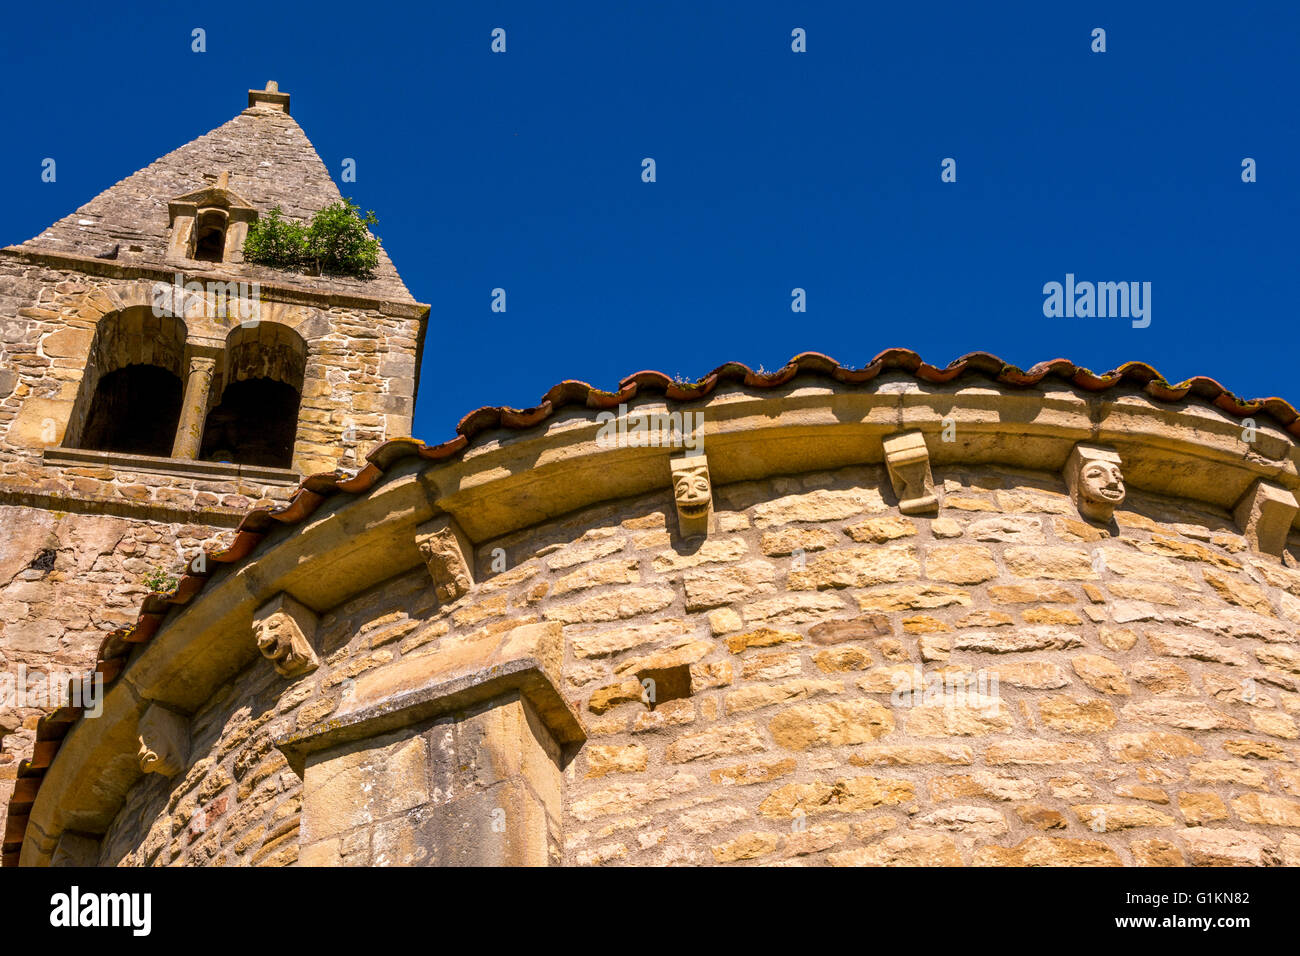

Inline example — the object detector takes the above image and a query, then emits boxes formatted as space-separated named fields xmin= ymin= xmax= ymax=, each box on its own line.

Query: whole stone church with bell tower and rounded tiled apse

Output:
xmin=0 ymin=83 xmax=1300 ymax=866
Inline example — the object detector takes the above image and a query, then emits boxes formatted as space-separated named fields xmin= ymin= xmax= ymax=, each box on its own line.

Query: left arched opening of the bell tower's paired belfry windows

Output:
xmin=64 ymin=306 xmax=186 ymax=458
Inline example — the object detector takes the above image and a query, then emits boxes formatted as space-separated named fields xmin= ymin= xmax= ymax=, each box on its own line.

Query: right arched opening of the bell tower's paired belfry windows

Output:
xmin=199 ymin=321 xmax=307 ymax=468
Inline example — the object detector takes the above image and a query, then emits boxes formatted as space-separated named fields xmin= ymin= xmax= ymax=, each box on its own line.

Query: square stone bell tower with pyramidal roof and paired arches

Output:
xmin=0 ymin=82 xmax=429 ymax=840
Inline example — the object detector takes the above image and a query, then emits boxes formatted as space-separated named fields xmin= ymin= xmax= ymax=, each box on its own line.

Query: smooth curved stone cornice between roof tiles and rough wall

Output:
xmin=10 ymin=356 xmax=1300 ymax=865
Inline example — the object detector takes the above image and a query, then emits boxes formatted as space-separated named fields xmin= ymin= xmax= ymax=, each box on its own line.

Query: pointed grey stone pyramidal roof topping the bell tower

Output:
xmin=17 ymin=83 xmax=413 ymax=302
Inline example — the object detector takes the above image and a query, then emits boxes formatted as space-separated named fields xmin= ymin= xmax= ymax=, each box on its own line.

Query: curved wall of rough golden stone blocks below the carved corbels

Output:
xmin=86 ymin=467 xmax=1300 ymax=865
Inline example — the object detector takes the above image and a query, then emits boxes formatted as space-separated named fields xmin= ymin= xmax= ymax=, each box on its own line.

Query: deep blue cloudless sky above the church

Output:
xmin=0 ymin=0 xmax=1300 ymax=441
